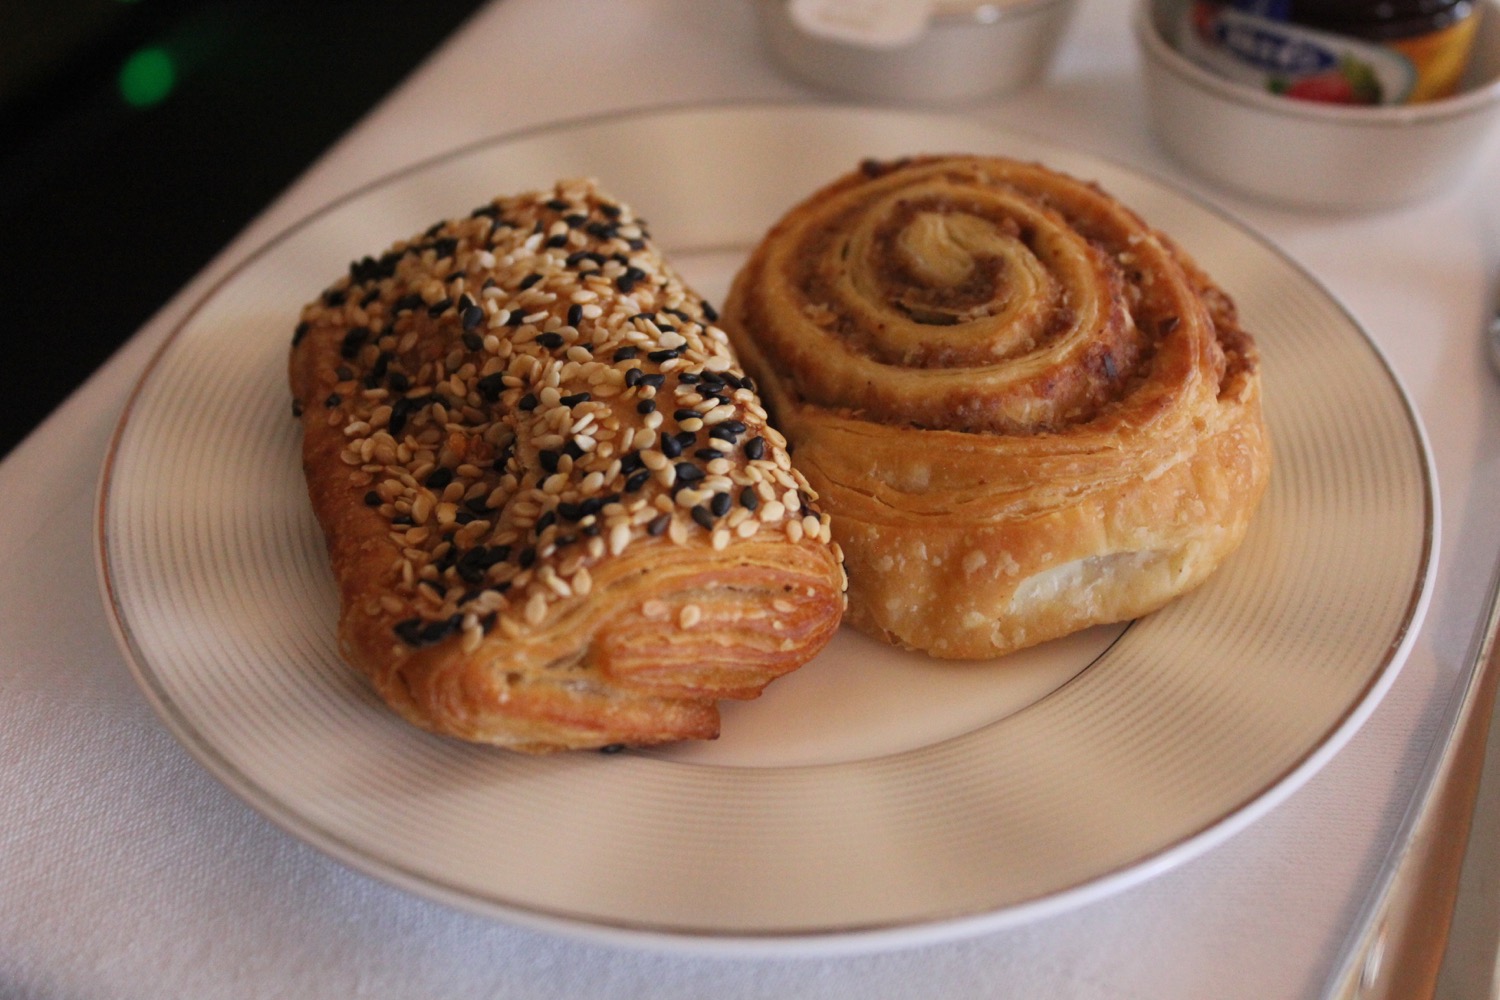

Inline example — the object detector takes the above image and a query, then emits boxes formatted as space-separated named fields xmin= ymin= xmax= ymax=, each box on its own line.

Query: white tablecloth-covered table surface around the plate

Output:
xmin=0 ymin=0 xmax=1500 ymax=1000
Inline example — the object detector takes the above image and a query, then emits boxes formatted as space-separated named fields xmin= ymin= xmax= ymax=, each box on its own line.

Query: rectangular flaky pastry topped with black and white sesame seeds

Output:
xmin=290 ymin=181 xmax=845 ymax=753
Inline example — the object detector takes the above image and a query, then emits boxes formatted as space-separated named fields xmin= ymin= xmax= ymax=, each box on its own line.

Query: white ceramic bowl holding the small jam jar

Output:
xmin=1134 ymin=0 xmax=1500 ymax=211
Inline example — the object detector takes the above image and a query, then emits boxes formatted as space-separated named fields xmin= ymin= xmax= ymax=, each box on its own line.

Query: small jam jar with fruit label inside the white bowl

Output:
xmin=1178 ymin=0 xmax=1479 ymax=105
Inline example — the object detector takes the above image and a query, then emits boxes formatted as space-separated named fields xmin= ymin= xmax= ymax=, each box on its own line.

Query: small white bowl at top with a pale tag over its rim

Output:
xmin=753 ymin=0 xmax=1076 ymax=103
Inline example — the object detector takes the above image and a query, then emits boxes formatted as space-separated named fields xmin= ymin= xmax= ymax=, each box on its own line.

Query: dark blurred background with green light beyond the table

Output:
xmin=0 ymin=0 xmax=482 ymax=454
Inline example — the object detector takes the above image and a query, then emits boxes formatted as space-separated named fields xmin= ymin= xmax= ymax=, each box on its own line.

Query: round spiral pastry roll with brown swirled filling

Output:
xmin=723 ymin=156 xmax=1271 ymax=658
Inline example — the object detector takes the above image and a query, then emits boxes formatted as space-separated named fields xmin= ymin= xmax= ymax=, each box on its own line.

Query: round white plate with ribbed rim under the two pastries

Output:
xmin=99 ymin=106 xmax=1437 ymax=952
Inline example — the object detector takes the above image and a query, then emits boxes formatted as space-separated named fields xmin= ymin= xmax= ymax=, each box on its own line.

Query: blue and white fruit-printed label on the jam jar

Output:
xmin=1178 ymin=0 xmax=1418 ymax=105
